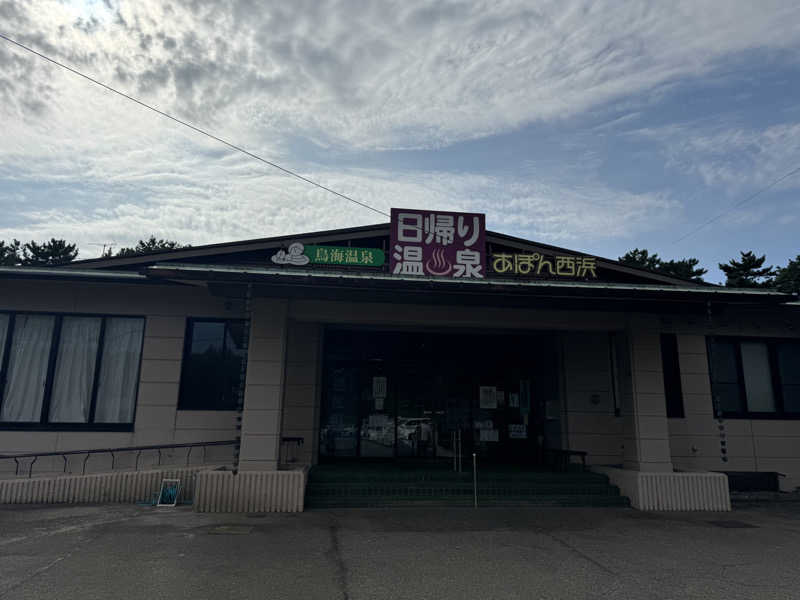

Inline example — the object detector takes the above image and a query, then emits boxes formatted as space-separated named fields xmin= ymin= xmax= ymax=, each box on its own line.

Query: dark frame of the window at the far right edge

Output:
xmin=706 ymin=335 xmax=800 ymax=421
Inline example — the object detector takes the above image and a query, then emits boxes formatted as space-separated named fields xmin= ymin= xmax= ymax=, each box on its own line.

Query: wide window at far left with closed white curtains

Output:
xmin=0 ymin=313 xmax=144 ymax=429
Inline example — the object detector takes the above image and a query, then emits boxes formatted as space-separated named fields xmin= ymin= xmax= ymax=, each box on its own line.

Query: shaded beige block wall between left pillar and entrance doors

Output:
xmin=281 ymin=321 xmax=322 ymax=465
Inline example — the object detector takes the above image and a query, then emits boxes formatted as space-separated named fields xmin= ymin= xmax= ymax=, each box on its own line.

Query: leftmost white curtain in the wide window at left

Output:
xmin=0 ymin=314 xmax=55 ymax=423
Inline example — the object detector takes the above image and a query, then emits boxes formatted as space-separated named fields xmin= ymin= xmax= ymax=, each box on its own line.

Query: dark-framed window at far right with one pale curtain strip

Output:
xmin=708 ymin=337 xmax=800 ymax=419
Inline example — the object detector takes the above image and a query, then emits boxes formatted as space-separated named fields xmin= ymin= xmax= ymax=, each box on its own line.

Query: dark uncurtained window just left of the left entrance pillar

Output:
xmin=178 ymin=319 xmax=247 ymax=410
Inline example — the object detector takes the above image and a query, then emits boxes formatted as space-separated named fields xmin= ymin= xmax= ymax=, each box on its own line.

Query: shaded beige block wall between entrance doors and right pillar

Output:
xmin=560 ymin=332 xmax=623 ymax=465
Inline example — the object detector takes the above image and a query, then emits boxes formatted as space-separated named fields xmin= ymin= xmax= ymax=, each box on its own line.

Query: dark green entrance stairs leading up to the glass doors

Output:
xmin=305 ymin=462 xmax=630 ymax=509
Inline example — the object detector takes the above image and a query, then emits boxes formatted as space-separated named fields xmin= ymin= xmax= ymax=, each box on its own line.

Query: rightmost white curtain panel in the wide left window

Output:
xmin=94 ymin=318 xmax=144 ymax=423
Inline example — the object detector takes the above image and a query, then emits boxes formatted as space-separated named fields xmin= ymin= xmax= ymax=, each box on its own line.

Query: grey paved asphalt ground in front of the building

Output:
xmin=0 ymin=505 xmax=800 ymax=600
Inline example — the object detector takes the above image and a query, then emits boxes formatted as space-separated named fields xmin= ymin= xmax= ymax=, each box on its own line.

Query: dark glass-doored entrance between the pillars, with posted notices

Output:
xmin=319 ymin=328 xmax=561 ymax=464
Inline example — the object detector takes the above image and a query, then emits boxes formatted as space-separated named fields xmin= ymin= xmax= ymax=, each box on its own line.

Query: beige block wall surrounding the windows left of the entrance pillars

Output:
xmin=0 ymin=281 xmax=243 ymax=476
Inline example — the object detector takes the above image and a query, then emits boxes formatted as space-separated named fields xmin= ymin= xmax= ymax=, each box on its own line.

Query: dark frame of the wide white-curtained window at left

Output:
xmin=0 ymin=310 xmax=147 ymax=432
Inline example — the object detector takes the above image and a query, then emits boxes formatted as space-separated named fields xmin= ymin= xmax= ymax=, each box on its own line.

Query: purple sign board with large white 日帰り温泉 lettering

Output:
xmin=389 ymin=208 xmax=486 ymax=279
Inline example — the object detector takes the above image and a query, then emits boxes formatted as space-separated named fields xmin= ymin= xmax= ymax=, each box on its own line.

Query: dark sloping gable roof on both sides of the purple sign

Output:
xmin=62 ymin=223 xmax=704 ymax=286
